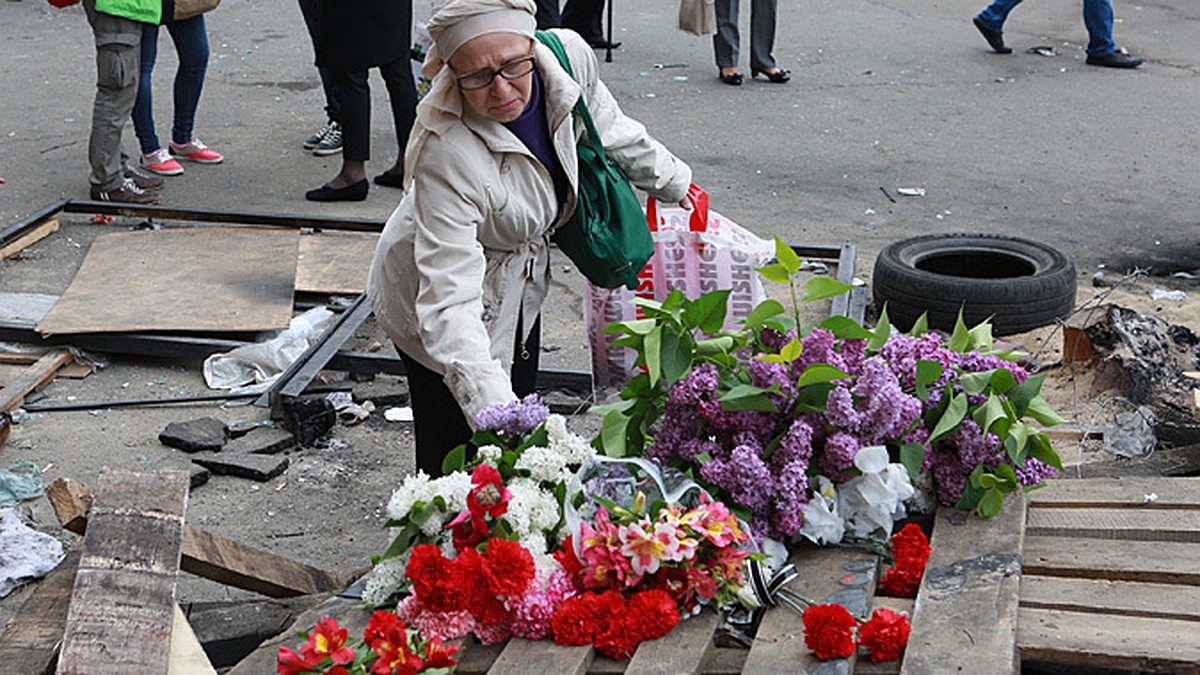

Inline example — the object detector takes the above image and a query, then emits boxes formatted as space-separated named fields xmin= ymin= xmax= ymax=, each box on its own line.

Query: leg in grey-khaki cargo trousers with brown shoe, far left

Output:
xmin=83 ymin=0 xmax=160 ymax=204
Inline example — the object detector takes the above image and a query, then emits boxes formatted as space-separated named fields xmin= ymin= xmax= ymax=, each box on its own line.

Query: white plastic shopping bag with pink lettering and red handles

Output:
xmin=584 ymin=185 xmax=775 ymax=393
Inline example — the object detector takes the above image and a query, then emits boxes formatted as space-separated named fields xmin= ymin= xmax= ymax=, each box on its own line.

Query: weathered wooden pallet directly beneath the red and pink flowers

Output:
xmin=228 ymin=500 xmax=1025 ymax=675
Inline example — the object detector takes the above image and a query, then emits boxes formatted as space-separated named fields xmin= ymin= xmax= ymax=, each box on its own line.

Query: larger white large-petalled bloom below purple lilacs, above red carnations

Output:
xmin=838 ymin=446 xmax=914 ymax=537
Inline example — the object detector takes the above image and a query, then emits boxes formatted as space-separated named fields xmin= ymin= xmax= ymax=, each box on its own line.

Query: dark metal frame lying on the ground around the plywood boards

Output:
xmin=0 ymin=198 xmax=866 ymax=403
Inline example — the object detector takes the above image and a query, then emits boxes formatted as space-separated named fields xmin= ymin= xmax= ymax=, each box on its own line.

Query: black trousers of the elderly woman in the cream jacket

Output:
xmin=397 ymin=316 xmax=541 ymax=478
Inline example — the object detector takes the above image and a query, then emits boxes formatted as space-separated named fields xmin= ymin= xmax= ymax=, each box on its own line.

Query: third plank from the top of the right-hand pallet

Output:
xmin=1021 ymin=537 xmax=1200 ymax=586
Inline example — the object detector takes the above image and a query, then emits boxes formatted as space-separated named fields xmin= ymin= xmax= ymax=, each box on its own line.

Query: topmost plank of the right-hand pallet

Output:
xmin=1030 ymin=476 xmax=1200 ymax=506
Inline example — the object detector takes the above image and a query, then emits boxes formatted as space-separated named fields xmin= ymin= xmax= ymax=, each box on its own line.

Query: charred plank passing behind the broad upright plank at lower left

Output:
xmin=46 ymin=478 xmax=347 ymax=598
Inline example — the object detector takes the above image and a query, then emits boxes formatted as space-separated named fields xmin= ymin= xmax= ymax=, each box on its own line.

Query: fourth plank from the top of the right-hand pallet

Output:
xmin=1021 ymin=573 xmax=1200 ymax=621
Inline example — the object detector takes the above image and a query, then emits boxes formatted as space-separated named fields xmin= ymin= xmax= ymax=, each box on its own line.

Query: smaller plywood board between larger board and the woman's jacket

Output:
xmin=296 ymin=232 xmax=379 ymax=295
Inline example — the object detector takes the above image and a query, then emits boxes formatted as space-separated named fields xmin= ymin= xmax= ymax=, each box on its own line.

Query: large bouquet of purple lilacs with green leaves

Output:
xmin=601 ymin=239 xmax=1061 ymax=543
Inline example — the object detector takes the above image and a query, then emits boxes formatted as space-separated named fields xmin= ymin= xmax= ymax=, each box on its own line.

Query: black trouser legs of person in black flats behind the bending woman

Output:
xmin=330 ymin=54 xmax=416 ymax=162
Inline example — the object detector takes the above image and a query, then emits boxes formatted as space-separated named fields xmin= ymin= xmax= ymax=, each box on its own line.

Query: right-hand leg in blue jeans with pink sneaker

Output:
xmin=167 ymin=14 xmax=224 ymax=165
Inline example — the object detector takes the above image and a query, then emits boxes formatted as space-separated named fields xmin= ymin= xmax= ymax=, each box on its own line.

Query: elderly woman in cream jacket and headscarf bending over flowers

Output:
xmin=367 ymin=0 xmax=691 ymax=476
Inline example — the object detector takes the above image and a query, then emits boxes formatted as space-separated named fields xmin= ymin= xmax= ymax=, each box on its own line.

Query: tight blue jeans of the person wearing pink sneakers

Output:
xmin=133 ymin=14 xmax=209 ymax=155
